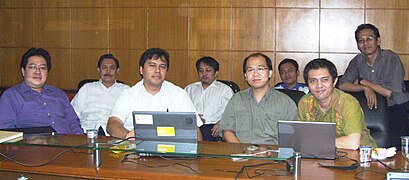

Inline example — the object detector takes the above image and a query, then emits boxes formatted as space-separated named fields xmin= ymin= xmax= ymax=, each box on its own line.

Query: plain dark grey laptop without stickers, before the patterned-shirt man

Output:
xmin=278 ymin=121 xmax=336 ymax=159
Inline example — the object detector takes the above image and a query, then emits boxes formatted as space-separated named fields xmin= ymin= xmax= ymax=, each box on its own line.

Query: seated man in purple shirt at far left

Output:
xmin=0 ymin=48 xmax=84 ymax=134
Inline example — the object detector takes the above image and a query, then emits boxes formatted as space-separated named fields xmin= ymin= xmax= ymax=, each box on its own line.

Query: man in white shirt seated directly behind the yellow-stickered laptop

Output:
xmin=107 ymin=48 xmax=203 ymax=141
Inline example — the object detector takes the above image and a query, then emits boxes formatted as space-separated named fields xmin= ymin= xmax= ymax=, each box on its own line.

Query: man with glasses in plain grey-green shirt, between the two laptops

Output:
xmin=219 ymin=53 xmax=297 ymax=144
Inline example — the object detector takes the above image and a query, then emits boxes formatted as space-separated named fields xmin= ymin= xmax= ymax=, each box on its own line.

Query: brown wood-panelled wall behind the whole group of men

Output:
xmin=0 ymin=0 xmax=409 ymax=89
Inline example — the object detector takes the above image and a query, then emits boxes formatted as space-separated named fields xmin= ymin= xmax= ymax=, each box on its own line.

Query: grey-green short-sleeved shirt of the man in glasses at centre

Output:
xmin=219 ymin=88 xmax=297 ymax=144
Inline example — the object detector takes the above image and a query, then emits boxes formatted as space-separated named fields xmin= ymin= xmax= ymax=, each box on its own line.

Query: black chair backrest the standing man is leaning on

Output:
xmin=347 ymin=91 xmax=392 ymax=147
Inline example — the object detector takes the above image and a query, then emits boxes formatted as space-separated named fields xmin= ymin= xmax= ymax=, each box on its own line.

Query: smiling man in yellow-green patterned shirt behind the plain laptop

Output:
xmin=297 ymin=59 xmax=377 ymax=149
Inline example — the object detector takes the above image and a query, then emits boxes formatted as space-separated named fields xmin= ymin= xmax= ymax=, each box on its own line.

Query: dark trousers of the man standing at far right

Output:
xmin=388 ymin=104 xmax=409 ymax=150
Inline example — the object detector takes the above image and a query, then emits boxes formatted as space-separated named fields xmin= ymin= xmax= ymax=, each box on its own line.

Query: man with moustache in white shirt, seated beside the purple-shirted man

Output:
xmin=71 ymin=54 xmax=129 ymax=134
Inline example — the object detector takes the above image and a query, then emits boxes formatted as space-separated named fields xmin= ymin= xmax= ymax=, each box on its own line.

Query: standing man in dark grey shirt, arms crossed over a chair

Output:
xmin=339 ymin=24 xmax=409 ymax=147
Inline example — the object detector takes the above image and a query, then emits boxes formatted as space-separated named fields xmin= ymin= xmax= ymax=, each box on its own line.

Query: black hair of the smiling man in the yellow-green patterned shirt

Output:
xmin=303 ymin=58 xmax=338 ymax=85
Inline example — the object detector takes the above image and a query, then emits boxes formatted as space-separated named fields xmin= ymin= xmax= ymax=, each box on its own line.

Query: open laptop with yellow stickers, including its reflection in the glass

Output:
xmin=132 ymin=111 xmax=197 ymax=156
